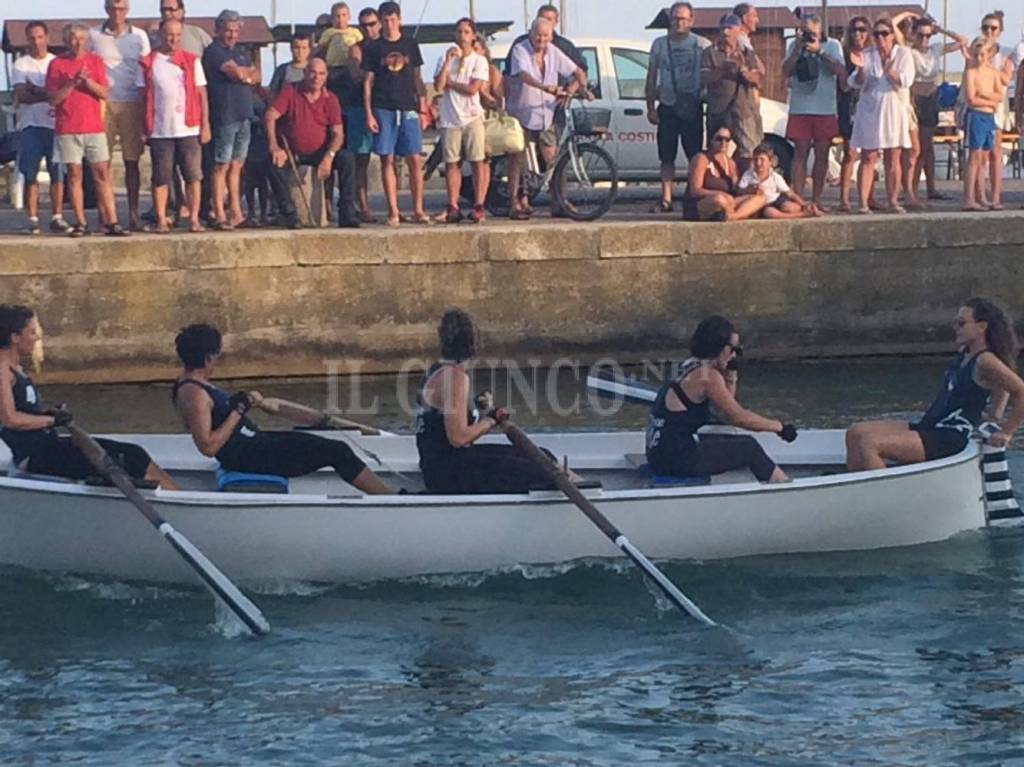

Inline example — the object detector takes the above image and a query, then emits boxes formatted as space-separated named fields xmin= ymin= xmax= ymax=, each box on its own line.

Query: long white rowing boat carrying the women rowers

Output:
xmin=0 ymin=427 xmax=1007 ymax=582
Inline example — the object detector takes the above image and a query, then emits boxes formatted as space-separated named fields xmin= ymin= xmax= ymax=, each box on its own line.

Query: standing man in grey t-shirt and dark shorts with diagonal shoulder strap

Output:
xmin=644 ymin=1 xmax=711 ymax=213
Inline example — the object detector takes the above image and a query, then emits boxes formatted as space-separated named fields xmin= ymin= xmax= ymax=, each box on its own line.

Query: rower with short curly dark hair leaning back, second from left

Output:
xmin=171 ymin=325 xmax=393 ymax=494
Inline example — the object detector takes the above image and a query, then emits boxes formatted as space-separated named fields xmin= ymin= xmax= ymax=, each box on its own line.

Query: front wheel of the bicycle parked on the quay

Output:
xmin=551 ymin=142 xmax=618 ymax=221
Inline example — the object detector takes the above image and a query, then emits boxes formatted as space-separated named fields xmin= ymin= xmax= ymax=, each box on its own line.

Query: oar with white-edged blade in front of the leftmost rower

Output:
xmin=65 ymin=424 xmax=270 ymax=636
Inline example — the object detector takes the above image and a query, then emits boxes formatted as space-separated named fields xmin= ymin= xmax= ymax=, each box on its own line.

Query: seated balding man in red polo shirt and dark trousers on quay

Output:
xmin=264 ymin=58 xmax=359 ymax=229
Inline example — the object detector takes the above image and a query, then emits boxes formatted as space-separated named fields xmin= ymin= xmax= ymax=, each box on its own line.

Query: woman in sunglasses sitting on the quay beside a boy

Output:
xmin=683 ymin=125 xmax=767 ymax=221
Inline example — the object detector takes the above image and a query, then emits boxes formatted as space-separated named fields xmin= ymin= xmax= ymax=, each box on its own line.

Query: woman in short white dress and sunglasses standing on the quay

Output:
xmin=849 ymin=18 xmax=914 ymax=213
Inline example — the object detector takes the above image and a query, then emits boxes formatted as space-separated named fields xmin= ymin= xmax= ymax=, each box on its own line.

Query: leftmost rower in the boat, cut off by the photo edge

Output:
xmin=0 ymin=304 xmax=178 ymax=489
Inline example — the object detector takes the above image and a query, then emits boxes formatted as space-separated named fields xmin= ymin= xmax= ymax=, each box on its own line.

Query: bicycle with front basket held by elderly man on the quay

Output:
xmin=486 ymin=95 xmax=618 ymax=221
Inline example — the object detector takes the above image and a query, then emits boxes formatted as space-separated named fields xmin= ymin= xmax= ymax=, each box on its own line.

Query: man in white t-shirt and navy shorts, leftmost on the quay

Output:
xmin=10 ymin=22 xmax=71 ymax=235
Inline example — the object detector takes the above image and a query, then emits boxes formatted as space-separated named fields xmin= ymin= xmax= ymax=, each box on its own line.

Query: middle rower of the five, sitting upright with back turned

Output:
xmin=416 ymin=309 xmax=552 ymax=495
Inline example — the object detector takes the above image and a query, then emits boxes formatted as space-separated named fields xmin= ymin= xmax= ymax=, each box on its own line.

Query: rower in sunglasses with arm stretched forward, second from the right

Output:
xmin=647 ymin=315 xmax=797 ymax=482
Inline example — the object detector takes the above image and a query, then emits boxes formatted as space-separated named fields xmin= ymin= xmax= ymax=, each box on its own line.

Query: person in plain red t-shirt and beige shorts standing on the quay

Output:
xmin=46 ymin=24 xmax=128 ymax=237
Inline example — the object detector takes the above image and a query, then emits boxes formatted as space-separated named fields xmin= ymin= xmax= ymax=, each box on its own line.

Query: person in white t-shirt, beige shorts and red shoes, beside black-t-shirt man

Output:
xmin=434 ymin=18 xmax=489 ymax=223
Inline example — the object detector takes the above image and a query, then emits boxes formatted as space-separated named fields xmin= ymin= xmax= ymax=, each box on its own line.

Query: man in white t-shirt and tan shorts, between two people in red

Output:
xmin=89 ymin=0 xmax=150 ymax=229
